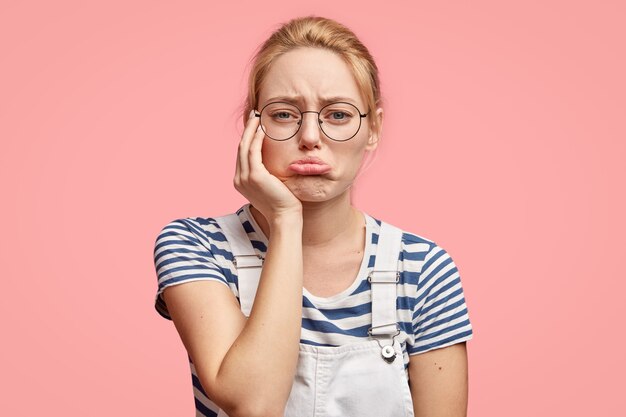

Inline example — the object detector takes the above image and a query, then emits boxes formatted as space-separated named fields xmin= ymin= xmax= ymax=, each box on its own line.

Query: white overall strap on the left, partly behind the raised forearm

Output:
xmin=215 ymin=213 xmax=263 ymax=317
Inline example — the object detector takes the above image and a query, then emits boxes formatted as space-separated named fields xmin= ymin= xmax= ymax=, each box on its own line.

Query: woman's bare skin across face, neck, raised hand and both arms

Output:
xmin=163 ymin=48 xmax=467 ymax=417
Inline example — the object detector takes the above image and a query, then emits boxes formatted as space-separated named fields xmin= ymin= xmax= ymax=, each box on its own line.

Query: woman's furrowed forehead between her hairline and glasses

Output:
xmin=259 ymin=48 xmax=364 ymax=107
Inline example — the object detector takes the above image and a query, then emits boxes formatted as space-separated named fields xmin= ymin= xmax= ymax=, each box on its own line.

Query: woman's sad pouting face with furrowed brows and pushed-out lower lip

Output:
xmin=257 ymin=48 xmax=382 ymax=202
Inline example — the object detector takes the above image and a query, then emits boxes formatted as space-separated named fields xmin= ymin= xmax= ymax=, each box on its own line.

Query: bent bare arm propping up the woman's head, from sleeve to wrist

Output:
xmin=163 ymin=213 xmax=302 ymax=417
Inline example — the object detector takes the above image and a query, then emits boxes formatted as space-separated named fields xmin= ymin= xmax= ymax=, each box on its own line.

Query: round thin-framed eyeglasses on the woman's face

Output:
xmin=254 ymin=101 xmax=367 ymax=142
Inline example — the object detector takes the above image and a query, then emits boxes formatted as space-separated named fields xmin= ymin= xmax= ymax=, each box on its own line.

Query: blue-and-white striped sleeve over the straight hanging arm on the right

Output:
xmin=407 ymin=244 xmax=473 ymax=355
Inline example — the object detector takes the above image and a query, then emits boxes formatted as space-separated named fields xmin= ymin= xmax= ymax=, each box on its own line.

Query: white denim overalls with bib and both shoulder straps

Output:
xmin=216 ymin=214 xmax=414 ymax=417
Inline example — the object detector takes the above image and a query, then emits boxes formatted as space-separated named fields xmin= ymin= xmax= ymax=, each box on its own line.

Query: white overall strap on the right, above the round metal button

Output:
xmin=367 ymin=222 xmax=402 ymax=336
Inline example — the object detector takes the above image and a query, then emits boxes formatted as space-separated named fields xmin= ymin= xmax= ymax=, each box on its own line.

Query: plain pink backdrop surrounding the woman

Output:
xmin=0 ymin=0 xmax=626 ymax=417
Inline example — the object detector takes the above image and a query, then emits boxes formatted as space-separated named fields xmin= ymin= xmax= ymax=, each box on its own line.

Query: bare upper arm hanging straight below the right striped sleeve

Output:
xmin=409 ymin=342 xmax=468 ymax=417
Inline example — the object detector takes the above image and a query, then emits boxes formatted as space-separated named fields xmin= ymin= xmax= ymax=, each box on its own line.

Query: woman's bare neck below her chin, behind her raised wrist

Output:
xmin=244 ymin=191 xmax=365 ymax=249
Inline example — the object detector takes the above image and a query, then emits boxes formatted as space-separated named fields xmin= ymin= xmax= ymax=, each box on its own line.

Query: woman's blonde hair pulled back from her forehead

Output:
xmin=242 ymin=16 xmax=382 ymax=128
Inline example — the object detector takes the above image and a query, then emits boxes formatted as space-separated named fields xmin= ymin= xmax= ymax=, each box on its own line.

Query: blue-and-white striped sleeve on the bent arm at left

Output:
xmin=154 ymin=219 xmax=228 ymax=320
